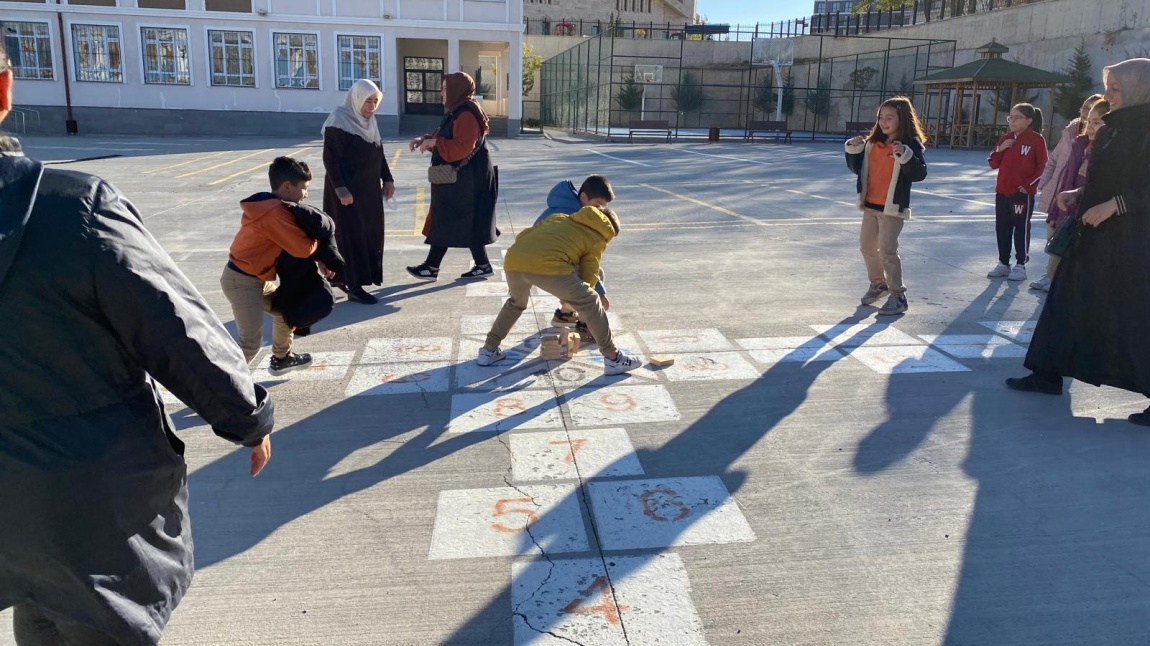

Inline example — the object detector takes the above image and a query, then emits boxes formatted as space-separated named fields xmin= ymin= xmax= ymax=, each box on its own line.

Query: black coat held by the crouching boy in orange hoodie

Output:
xmin=271 ymin=202 xmax=345 ymax=336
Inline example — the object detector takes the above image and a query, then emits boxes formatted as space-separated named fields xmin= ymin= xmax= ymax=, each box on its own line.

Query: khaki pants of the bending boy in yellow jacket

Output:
xmin=485 ymin=271 xmax=618 ymax=359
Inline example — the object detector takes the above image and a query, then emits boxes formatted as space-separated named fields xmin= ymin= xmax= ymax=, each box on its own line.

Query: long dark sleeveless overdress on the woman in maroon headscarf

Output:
xmin=426 ymin=102 xmax=499 ymax=248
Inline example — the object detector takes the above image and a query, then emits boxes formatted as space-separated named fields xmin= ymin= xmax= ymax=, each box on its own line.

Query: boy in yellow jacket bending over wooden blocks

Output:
xmin=477 ymin=206 xmax=642 ymax=375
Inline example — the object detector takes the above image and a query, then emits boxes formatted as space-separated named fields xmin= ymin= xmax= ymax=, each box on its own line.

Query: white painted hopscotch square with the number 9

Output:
xmin=565 ymin=385 xmax=680 ymax=429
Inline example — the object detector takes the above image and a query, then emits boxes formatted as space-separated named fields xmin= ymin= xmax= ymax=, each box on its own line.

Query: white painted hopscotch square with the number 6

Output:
xmin=587 ymin=476 xmax=754 ymax=549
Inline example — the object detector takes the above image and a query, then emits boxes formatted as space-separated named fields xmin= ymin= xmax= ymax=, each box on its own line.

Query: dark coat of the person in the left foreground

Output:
xmin=0 ymin=147 xmax=273 ymax=646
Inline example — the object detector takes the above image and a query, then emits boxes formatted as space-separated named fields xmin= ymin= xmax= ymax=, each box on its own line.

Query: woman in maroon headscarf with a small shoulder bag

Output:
xmin=407 ymin=71 xmax=499 ymax=280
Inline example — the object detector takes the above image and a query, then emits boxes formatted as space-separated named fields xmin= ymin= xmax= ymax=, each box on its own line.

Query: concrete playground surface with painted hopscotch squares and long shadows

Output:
xmin=0 ymin=132 xmax=1150 ymax=646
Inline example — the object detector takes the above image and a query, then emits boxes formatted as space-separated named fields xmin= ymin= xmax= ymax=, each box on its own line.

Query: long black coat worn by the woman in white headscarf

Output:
xmin=323 ymin=128 xmax=394 ymax=287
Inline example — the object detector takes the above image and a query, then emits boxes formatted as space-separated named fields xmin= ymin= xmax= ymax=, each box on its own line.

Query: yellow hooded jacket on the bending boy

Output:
xmin=504 ymin=207 xmax=615 ymax=286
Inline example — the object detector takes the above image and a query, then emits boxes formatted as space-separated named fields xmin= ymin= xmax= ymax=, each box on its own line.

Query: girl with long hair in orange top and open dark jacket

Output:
xmin=846 ymin=97 xmax=927 ymax=315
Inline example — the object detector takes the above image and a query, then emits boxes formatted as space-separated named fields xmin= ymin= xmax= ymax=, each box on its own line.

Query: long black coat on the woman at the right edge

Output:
xmin=1026 ymin=105 xmax=1150 ymax=397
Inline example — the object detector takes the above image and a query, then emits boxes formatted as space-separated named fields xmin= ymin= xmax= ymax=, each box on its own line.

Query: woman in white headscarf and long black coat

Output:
xmin=322 ymin=78 xmax=396 ymax=303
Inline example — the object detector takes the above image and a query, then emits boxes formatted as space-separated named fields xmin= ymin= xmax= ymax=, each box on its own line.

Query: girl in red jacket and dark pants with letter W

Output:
xmin=987 ymin=103 xmax=1047 ymax=280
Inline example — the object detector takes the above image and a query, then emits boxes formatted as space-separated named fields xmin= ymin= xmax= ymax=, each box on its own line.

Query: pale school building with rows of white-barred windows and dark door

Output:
xmin=0 ymin=0 xmax=523 ymax=136
